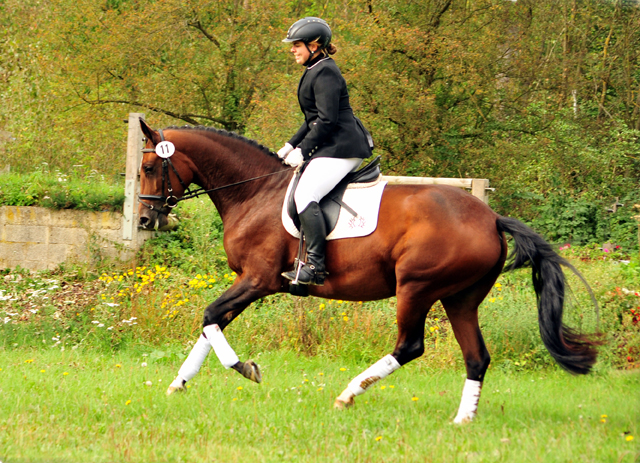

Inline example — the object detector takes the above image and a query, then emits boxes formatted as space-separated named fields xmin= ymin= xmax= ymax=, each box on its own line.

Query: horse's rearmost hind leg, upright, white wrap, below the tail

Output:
xmin=441 ymin=265 xmax=502 ymax=424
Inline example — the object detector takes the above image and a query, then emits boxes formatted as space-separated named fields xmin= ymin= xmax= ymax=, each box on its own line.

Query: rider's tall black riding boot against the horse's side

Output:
xmin=282 ymin=202 xmax=327 ymax=286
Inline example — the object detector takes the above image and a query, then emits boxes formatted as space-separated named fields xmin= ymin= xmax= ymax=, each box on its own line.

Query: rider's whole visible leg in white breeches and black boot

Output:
xmin=283 ymin=158 xmax=362 ymax=285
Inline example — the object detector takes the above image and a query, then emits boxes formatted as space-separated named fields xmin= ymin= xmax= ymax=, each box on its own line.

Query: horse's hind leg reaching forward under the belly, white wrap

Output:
xmin=334 ymin=285 xmax=432 ymax=408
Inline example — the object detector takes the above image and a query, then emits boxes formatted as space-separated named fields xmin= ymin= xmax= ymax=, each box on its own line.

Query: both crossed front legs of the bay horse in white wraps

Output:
xmin=167 ymin=278 xmax=272 ymax=394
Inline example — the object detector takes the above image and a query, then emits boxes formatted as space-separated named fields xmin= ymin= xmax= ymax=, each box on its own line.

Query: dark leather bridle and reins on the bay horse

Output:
xmin=138 ymin=129 xmax=293 ymax=215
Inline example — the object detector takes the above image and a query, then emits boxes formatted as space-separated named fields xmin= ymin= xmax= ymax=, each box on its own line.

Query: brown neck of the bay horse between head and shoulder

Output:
xmin=196 ymin=138 xmax=290 ymax=222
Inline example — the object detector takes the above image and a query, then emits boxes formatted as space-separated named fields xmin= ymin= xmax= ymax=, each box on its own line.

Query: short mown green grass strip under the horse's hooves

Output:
xmin=0 ymin=346 xmax=640 ymax=463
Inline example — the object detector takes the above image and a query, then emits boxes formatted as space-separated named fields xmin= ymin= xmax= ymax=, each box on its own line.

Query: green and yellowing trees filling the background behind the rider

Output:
xmin=0 ymin=0 xmax=640 ymax=205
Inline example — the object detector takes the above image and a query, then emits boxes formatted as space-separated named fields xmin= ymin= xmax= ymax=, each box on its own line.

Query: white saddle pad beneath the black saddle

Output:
xmin=282 ymin=179 xmax=387 ymax=240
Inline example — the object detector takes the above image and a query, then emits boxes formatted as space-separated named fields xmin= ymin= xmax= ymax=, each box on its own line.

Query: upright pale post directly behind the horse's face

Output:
xmin=122 ymin=113 xmax=144 ymax=241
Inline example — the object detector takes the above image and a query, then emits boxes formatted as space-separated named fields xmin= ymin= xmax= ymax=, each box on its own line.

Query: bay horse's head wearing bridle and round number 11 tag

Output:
xmin=138 ymin=119 xmax=194 ymax=230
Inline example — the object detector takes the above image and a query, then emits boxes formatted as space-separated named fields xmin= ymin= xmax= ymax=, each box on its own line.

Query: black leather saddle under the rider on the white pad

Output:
xmin=287 ymin=156 xmax=381 ymax=234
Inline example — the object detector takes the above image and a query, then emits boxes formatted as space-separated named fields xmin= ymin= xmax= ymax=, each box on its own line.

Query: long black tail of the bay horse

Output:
xmin=497 ymin=217 xmax=601 ymax=374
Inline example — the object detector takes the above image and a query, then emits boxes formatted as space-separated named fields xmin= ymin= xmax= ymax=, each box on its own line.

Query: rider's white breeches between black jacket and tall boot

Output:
xmin=294 ymin=158 xmax=362 ymax=214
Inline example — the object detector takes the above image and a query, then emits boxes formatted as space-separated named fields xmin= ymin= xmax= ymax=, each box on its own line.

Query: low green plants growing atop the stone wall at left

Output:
xmin=0 ymin=171 xmax=124 ymax=211
